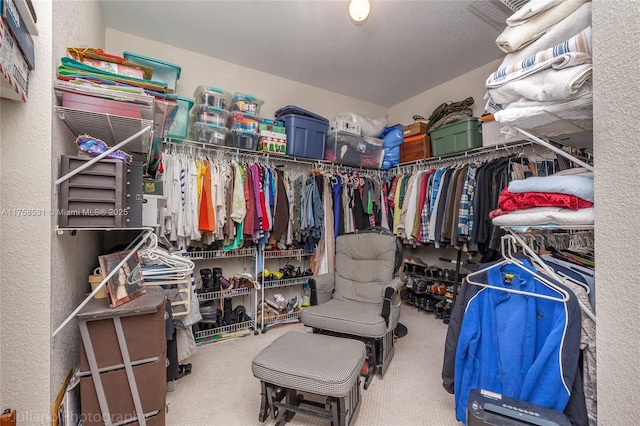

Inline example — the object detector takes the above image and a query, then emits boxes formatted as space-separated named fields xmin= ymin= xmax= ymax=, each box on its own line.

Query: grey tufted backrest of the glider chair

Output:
xmin=332 ymin=231 xmax=398 ymax=305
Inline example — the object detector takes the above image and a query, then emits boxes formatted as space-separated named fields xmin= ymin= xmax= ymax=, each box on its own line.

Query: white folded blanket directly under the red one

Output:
xmin=491 ymin=207 xmax=595 ymax=226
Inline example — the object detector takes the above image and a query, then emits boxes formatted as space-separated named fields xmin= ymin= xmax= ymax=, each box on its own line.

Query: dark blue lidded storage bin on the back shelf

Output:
xmin=276 ymin=105 xmax=329 ymax=160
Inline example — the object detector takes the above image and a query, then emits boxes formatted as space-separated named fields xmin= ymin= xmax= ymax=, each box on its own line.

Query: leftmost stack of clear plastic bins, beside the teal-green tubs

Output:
xmin=192 ymin=86 xmax=231 ymax=145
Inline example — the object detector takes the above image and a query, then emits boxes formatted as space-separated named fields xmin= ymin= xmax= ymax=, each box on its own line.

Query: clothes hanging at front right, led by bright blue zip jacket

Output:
xmin=442 ymin=230 xmax=597 ymax=426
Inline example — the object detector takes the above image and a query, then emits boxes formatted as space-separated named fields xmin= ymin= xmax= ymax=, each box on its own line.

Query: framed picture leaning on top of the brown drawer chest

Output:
xmin=98 ymin=251 xmax=147 ymax=308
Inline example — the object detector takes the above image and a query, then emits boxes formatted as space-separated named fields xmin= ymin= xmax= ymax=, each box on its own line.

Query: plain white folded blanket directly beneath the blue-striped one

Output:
xmin=489 ymin=64 xmax=593 ymax=108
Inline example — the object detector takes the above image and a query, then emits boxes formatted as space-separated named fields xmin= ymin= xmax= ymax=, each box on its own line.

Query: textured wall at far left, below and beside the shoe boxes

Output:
xmin=0 ymin=0 xmax=53 ymax=425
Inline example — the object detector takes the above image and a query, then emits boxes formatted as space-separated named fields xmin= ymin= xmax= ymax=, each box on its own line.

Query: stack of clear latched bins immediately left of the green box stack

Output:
xmin=229 ymin=92 xmax=264 ymax=150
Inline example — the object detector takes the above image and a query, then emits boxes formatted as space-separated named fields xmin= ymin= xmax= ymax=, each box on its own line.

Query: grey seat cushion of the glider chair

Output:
xmin=300 ymin=299 xmax=387 ymax=338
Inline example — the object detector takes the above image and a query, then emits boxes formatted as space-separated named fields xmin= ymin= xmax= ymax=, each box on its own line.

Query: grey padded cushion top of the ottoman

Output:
xmin=251 ymin=331 xmax=367 ymax=398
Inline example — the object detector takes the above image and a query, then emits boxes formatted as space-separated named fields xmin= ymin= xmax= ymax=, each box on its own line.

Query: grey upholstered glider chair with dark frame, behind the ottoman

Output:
xmin=300 ymin=228 xmax=402 ymax=389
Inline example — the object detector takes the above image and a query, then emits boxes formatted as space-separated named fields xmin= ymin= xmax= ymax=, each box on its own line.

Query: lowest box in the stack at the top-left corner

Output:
xmin=0 ymin=18 xmax=29 ymax=102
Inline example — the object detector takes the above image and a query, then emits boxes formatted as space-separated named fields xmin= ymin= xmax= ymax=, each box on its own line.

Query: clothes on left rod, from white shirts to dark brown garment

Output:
xmin=159 ymin=144 xmax=304 ymax=250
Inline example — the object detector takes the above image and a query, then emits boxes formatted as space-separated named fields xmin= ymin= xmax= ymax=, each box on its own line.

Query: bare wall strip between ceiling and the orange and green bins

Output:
xmin=389 ymin=58 xmax=502 ymax=124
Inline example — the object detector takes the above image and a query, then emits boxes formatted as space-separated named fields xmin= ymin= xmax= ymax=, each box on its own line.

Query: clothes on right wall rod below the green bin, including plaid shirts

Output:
xmin=382 ymin=142 xmax=569 ymax=260
